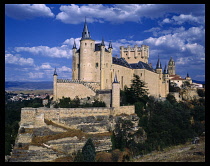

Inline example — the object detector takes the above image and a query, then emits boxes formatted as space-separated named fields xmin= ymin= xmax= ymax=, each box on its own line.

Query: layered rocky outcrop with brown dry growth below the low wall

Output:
xmin=10 ymin=114 xmax=144 ymax=162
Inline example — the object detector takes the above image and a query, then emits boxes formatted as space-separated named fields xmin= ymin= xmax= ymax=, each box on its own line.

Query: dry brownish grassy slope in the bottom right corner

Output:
xmin=131 ymin=137 xmax=205 ymax=162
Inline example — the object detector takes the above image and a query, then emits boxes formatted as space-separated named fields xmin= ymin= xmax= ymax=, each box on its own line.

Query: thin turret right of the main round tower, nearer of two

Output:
xmin=100 ymin=38 xmax=105 ymax=89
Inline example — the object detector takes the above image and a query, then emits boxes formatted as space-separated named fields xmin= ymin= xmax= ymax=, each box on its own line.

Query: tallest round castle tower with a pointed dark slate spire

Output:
xmin=79 ymin=20 xmax=95 ymax=82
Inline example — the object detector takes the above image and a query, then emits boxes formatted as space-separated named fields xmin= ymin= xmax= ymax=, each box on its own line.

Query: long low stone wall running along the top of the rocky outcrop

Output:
xmin=20 ymin=106 xmax=135 ymax=128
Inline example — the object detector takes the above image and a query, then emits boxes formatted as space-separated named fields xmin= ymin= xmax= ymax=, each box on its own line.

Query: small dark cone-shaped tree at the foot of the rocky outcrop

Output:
xmin=82 ymin=138 xmax=96 ymax=162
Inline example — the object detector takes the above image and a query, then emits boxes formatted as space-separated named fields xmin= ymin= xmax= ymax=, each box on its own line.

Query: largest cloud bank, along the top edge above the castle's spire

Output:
xmin=56 ymin=4 xmax=205 ymax=24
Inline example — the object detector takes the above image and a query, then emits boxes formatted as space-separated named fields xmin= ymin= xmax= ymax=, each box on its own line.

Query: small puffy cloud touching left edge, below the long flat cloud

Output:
xmin=5 ymin=54 xmax=34 ymax=66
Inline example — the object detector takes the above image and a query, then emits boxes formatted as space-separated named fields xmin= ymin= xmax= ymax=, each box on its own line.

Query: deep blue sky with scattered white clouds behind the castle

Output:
xmin=5 ymin=4 xmax=205 ymax=81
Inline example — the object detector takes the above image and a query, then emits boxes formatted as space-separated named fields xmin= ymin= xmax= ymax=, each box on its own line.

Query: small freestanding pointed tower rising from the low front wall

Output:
xmin=112 ymin=74 xmax=120 ymax=108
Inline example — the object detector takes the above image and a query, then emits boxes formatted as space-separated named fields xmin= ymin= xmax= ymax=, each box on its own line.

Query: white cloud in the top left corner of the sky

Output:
xmin=5 ymin=4 xmax=54 ymax=19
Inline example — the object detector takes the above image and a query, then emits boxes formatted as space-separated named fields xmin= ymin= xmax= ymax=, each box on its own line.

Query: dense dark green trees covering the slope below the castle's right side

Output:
xmin=117 ymin=76 xmax=205 ymax=159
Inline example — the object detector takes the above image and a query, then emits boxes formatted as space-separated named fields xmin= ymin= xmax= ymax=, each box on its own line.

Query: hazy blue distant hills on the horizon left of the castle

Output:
xmin=5 ymin=81 xmax=53 ymax=90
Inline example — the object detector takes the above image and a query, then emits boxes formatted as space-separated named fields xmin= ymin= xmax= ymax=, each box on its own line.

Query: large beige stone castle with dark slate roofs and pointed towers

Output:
xmin=53 ymin=21 xmax=190 ymax=107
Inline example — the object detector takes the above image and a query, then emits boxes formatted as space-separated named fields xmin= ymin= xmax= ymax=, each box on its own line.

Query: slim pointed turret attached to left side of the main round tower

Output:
xmin=72 ymin=40 xmax=79 ymax=80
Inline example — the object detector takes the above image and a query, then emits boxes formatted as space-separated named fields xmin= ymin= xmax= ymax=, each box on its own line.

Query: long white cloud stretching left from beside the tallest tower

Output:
xmin=15 ymin=45 xmax=72 ymax=59
